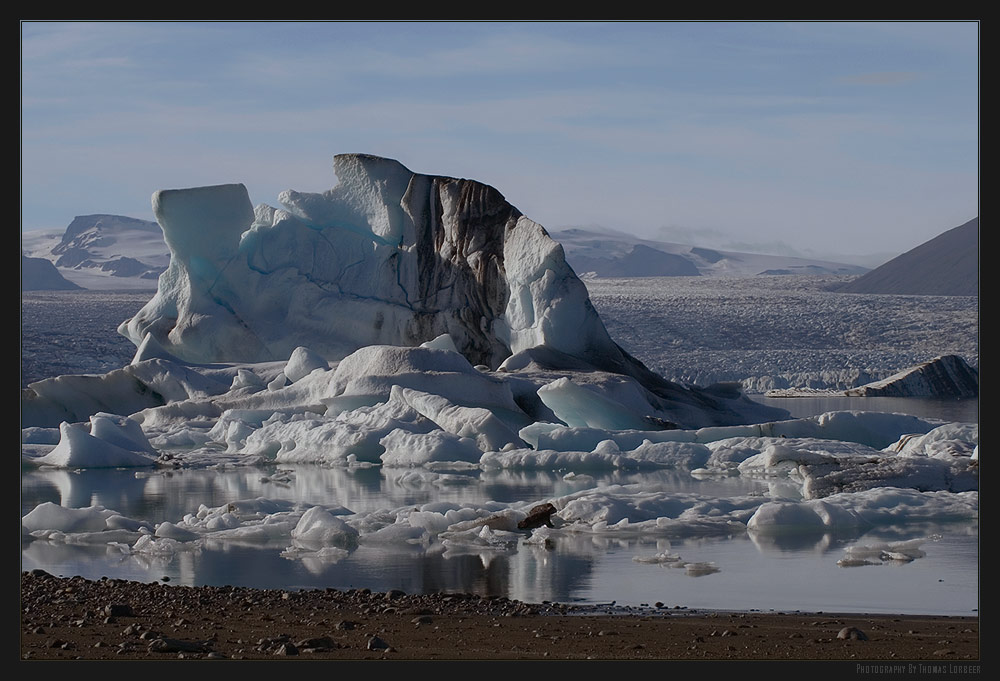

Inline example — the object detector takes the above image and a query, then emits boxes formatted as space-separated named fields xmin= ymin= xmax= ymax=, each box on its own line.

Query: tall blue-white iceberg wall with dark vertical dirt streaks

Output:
xmin=121 ymin=154 xmax=620 ymax=368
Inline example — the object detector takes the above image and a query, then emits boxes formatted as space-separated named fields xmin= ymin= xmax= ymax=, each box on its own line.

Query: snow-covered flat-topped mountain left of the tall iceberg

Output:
xmin=22 ymin=215 xmax=170 ymax=289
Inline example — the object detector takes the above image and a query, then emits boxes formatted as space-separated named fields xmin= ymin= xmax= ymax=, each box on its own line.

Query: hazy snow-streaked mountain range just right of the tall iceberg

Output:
xmin=550 ymin=224 xmax=868 ymax=277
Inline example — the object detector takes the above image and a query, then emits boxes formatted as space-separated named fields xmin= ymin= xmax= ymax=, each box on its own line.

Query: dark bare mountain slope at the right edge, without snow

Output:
xmin=838 ymin=217 xmax=979 ymax=296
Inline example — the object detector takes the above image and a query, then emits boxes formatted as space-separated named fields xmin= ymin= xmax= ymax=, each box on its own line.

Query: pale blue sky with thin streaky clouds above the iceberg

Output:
xmin=21 ymin=22 xmax=979 ymax=256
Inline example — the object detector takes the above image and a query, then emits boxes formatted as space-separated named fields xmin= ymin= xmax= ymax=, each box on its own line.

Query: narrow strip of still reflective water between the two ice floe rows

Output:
xmin=21 ymin=464 xmax=772 ymax=523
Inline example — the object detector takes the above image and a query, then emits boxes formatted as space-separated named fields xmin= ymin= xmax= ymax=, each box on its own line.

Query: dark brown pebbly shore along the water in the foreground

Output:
xmin=20 ymin=571 xmax=980 ymax=660
